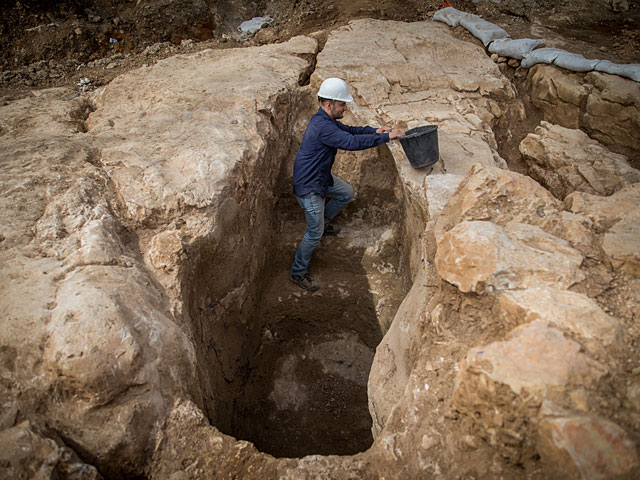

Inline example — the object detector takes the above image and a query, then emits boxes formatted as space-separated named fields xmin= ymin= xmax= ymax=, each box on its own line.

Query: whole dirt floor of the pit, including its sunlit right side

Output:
xmin=219 ymin=145 xmax=409 ymax=457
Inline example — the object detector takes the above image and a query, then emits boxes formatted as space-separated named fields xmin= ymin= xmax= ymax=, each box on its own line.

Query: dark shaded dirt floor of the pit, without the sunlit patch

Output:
xmin=232 ymin=189 xmax=382 ymax=457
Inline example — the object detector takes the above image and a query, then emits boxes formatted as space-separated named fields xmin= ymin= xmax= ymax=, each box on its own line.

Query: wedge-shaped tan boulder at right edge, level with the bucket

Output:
xmin=520 ymin=121 xmax=640 ymax=199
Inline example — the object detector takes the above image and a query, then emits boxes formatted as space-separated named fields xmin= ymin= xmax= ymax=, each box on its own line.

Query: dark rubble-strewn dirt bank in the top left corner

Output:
xmin=0 ymin=0 xmax=216 ymax=71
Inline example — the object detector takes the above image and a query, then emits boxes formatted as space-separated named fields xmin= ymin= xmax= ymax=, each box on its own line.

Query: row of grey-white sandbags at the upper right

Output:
xmin=433 ymin=7 xmax=640 ymax=82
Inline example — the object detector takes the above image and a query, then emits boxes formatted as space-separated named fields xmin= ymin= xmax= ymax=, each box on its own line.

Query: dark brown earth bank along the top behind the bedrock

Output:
xmin=0 ymin=0 xmax=640 ymax=101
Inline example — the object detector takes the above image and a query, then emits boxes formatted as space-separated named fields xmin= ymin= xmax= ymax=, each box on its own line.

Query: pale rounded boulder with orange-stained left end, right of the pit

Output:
xmin=435 ymin=221 xmax=584 ymax=292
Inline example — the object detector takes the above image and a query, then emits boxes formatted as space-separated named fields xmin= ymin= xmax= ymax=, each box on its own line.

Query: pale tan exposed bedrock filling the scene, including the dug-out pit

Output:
xmin=0 ymin=16 xmax=640 ymax=479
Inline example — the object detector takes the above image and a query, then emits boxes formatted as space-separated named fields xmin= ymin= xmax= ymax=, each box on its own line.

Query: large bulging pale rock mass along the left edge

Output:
xmin=0 ymin=89 xmax=198 ymax=474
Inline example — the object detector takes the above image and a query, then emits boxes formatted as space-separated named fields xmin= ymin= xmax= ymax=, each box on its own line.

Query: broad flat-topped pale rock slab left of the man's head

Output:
xmin=87 ymin=37 xmax=317 ymax=224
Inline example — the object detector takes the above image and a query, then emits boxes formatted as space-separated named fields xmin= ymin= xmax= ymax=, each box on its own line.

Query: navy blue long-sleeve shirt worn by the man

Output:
xmin=293 ymin=108 xmax=389 ymax=197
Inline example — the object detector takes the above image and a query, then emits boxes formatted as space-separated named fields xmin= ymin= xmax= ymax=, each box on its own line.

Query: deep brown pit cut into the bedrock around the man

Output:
xmin=185 ymin=105 xmax=409 ymax=457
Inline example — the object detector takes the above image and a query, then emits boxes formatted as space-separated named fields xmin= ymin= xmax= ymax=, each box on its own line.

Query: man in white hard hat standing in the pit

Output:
xmin=289 ymin=78 xmax=405 ymax=291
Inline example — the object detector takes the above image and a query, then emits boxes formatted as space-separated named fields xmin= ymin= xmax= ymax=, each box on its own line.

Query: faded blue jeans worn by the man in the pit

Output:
xmin=291 ymin=175 xmax=353 ymax=275
